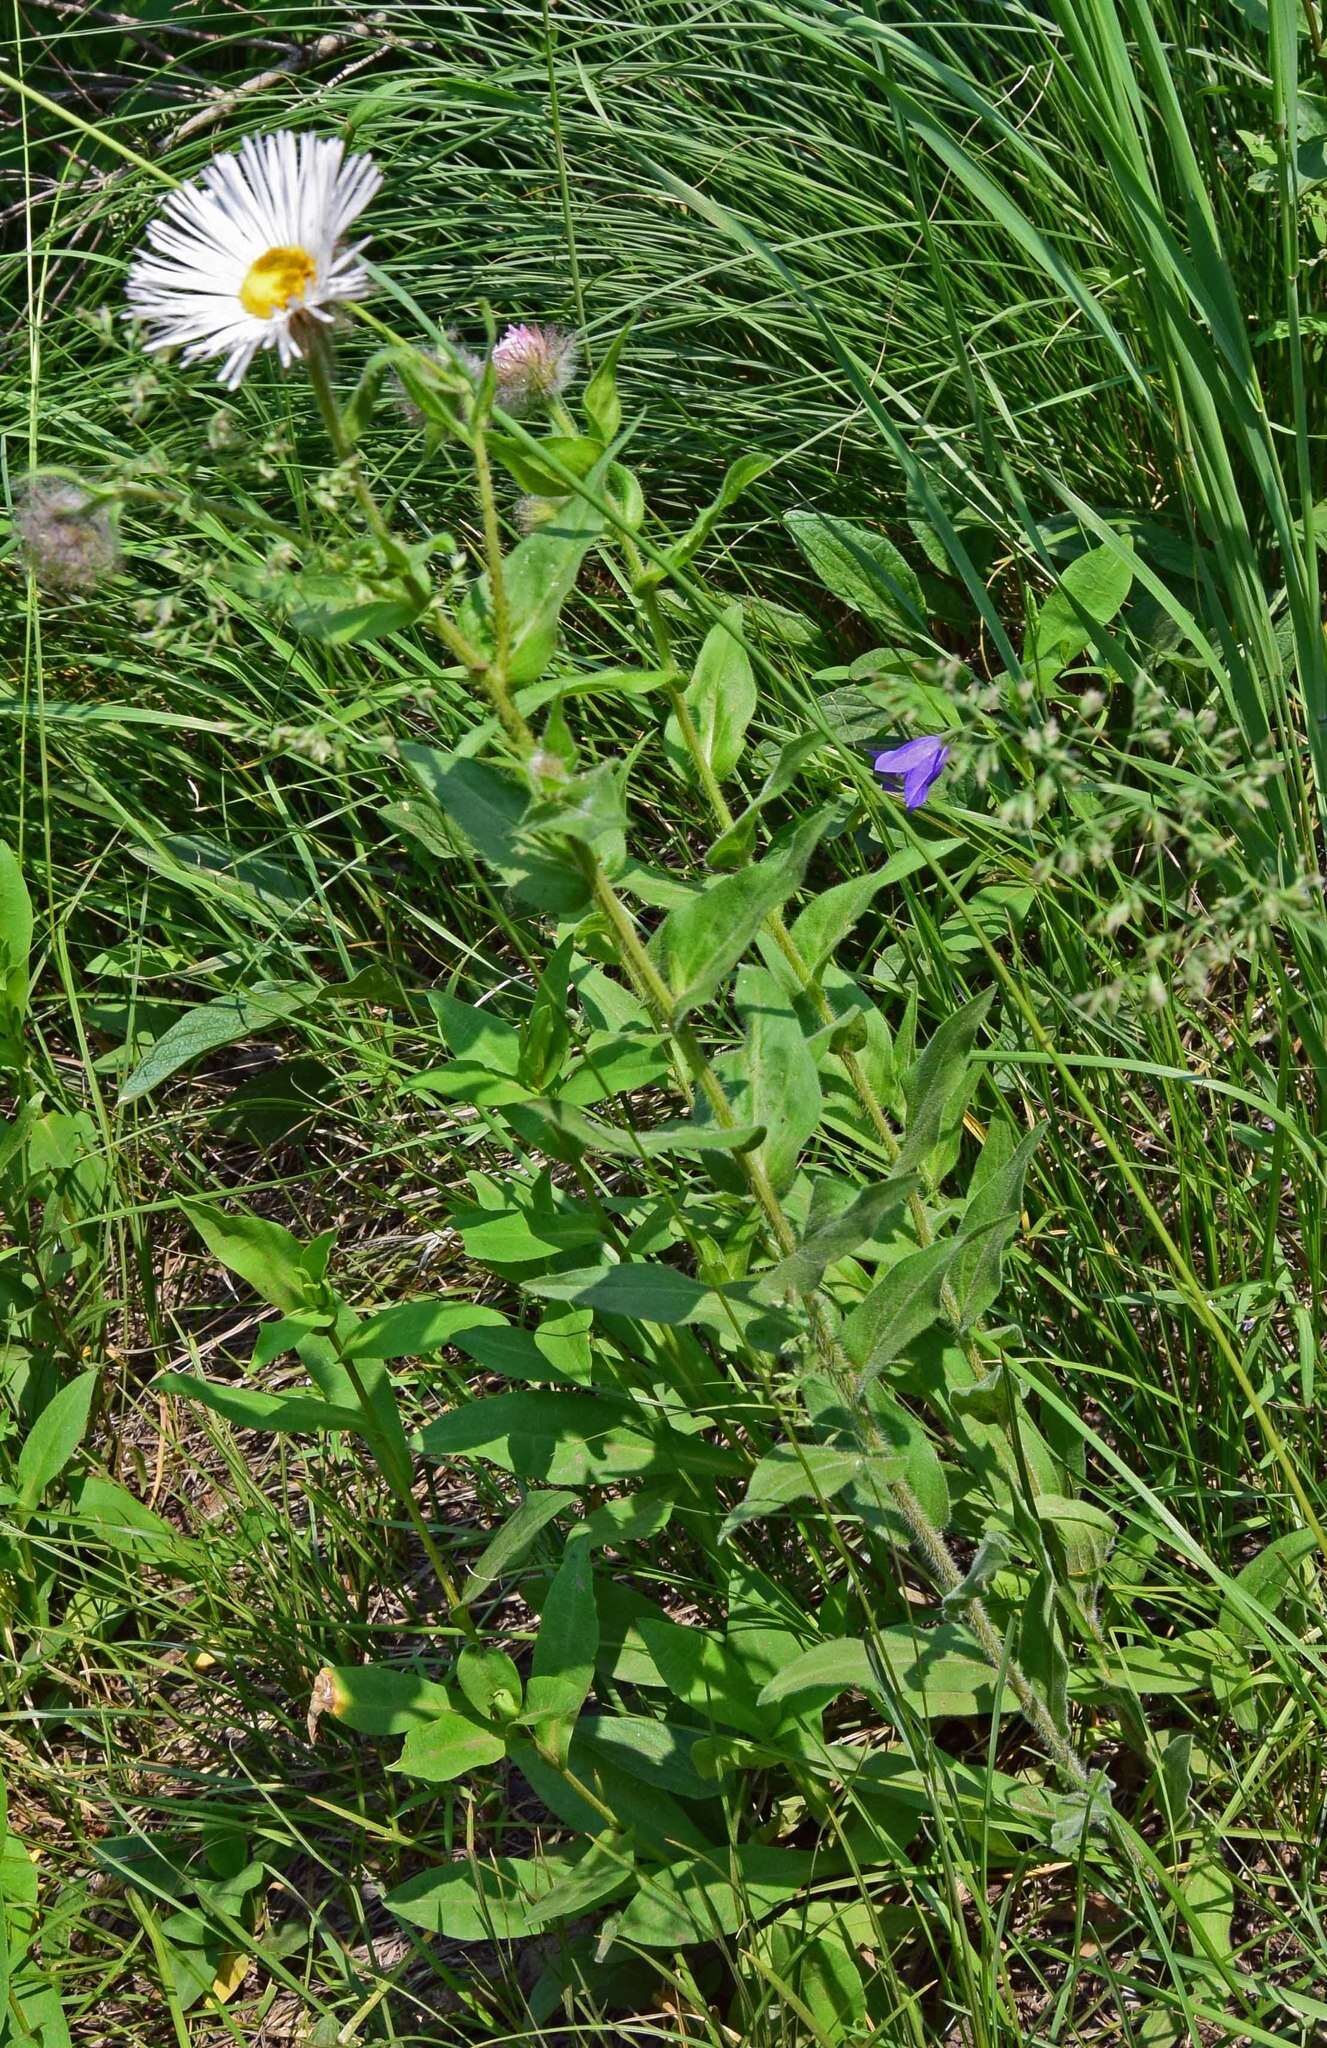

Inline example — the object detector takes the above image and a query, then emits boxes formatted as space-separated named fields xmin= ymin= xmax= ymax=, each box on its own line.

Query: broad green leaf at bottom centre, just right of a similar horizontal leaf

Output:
xmin=618 ymin=1841 xmax=829 ymax=1950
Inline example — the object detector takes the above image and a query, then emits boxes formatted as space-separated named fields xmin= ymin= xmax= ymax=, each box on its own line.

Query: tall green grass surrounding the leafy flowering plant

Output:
xmin=0 ymin=0 xmax=1327 ymax=2048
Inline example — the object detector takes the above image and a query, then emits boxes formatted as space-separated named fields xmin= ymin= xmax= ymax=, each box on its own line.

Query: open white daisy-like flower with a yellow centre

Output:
xmin=129 ymin=129 xmax=383 ymax=391
